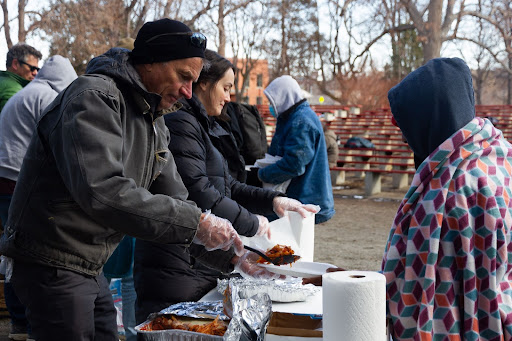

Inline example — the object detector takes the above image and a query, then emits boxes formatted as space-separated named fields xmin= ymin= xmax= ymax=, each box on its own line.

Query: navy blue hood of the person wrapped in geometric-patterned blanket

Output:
xmin=388 ymin=58 xmax=475 ymax=167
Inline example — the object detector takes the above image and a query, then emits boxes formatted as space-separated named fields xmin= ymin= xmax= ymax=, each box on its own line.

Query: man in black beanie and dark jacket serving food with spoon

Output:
xmin=0 ymin=19 xmax=270 ymax=341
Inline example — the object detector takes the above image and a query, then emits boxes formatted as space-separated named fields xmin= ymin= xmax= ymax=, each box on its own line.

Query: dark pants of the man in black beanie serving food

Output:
xmin=11 ymin=261 xmax=119 ymax=341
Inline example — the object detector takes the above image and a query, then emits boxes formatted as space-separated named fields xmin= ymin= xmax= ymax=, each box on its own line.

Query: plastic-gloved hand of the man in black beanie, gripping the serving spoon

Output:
xmin=192 ymin=211 xmax=245 ymax=255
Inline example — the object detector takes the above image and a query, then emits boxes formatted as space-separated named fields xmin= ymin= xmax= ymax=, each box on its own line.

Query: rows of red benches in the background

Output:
xmin=258 ymin=105 xmax=512 ymax=195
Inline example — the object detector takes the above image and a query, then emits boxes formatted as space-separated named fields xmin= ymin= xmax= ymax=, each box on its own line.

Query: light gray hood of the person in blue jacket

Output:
xmin=263 ymin=76 xmax=304 ymax=117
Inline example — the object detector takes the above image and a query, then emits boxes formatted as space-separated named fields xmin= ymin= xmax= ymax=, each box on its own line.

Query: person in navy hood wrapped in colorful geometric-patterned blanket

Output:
xmin=382 ymin=59 xmax=512 ymax=340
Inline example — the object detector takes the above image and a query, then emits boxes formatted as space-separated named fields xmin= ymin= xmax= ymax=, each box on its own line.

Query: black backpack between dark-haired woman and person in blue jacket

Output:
xmin=228 ymin=102 xmax=268 ymax=165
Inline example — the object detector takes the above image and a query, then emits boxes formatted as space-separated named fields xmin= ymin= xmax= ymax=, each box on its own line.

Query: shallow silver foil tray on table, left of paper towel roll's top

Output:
xmin=217 ymin=278 xmax=319 ymax=302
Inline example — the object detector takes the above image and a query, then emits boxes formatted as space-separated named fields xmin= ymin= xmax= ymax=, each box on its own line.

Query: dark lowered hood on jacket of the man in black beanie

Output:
xmin=85 ymin=47 xmax=163 ymax=111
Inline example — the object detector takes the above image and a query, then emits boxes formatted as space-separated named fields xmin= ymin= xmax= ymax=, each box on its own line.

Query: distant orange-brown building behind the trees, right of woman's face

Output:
xmin=231 ymin=59 xmax=269 ymax=105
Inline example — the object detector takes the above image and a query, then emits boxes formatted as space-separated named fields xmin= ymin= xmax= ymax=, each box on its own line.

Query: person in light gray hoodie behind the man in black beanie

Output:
xmin=0 ymin=55 xmax=77 ymax=339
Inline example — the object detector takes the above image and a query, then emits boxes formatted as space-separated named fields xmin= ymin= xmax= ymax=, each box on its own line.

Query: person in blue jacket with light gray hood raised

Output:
xmin=258 ymin=76 xmax=335 ymax=224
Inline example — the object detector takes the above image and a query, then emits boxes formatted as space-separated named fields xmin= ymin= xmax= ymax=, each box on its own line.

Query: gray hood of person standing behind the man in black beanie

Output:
xmin=33 ymin=55 xmax=77 ymax=93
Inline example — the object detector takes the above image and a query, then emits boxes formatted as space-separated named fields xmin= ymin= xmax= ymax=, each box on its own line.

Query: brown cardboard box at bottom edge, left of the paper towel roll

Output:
xmin=265 ymin=312 xmax=323 ymax=341
